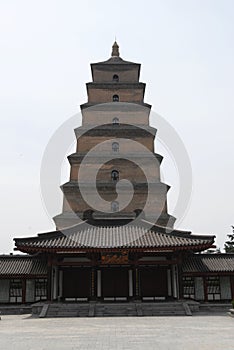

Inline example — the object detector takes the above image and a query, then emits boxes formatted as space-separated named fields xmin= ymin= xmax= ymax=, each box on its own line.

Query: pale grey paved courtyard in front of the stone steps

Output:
xmin=0 ymin=315 xmax=234 ymax=350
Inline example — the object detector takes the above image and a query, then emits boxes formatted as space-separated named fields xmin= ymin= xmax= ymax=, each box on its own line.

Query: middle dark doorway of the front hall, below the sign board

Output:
xmin=101 ymin=268 xmax=129 ymax=300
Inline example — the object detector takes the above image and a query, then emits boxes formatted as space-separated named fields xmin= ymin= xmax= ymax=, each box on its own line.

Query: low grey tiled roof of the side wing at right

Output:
xmin=182 ymin=254 xmax=234 ymax=273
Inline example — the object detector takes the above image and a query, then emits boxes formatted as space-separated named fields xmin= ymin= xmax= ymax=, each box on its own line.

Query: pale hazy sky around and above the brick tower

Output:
xmin=0 ymin=0 xmax=234 ymax=253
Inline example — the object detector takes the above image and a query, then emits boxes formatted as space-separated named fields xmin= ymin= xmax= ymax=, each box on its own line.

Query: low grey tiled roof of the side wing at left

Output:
xmin=0 ymin=255 xmax=47 ymax=277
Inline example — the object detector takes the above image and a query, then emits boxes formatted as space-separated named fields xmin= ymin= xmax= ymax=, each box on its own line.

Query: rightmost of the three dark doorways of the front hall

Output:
xmin=139 ymin=266 xmax=168 ymax=300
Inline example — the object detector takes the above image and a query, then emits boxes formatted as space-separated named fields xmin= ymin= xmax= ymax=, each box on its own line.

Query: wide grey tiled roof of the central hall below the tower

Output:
xmin=15 ymin=225 xmax=214 ymax=251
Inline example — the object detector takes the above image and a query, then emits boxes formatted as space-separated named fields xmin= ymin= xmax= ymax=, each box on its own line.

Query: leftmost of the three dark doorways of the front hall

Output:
xmin=62 ymin=267 xmax=91 ymax=300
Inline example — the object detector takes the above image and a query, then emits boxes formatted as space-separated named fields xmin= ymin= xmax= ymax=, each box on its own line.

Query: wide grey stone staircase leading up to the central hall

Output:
xmin=39 ymin=302 xmax=192 ymax=318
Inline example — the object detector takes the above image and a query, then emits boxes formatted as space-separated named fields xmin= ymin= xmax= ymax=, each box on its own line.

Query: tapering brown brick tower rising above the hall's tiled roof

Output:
xmin=54 ymin=42 xmax=175 ymax=229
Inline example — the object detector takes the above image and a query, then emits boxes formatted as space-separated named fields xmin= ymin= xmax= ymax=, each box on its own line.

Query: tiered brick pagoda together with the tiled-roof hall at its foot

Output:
xmin=15 ymin=42 xmax=214 ymax=301
